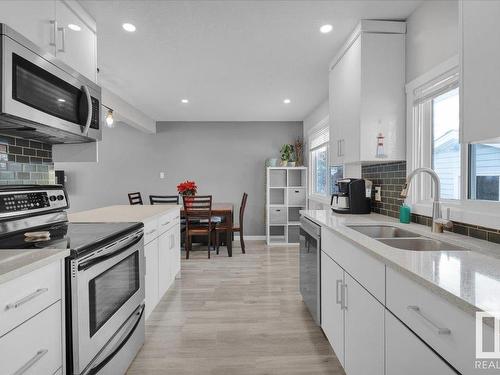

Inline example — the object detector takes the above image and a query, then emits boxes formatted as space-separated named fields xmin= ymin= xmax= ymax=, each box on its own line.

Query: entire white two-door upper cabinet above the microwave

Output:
xmin=0 ymin=0 xmax=97 ymax=82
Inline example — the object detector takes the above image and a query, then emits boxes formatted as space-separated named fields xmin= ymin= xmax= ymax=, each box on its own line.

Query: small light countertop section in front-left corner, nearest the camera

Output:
xmin=0 ymin=249 xmax=69 ymax=284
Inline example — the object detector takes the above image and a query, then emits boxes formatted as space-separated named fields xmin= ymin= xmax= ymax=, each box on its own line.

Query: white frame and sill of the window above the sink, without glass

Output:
xmin=406 ymin=56 xmax=500 ymax=229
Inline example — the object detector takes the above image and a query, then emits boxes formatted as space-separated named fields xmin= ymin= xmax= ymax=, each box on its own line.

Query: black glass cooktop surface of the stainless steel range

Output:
xmin=0 ymin=223 xmax=143 ymax=256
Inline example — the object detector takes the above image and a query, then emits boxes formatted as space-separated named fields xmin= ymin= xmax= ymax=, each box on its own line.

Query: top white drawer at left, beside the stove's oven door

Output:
xmin=0 ymin=261 xmax=62 ymax=338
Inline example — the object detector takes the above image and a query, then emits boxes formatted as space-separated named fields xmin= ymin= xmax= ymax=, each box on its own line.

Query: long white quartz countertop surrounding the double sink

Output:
xmin=301 ymin=210 xmax=500 ymax=315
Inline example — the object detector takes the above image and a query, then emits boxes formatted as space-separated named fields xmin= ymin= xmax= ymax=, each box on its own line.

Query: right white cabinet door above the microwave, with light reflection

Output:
xmin=56 ymin=0 xmax=97 ymax=82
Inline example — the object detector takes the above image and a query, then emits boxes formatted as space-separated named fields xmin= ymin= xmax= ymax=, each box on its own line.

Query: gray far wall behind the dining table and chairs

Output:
xmin=56 ymin=122 xmax=302 ymax=235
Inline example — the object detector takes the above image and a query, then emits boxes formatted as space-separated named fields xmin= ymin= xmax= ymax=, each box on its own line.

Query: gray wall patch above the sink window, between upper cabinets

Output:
xmin=406 ymin=0 xmax=458 ymax=82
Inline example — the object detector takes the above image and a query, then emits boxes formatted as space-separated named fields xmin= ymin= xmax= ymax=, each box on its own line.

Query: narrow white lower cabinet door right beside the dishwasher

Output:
xmin=321 ymin=252 xmax=344 ymax=365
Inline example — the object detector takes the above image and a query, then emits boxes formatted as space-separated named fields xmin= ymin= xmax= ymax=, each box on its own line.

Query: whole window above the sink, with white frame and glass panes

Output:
xmin=406 ymin=57 xmax=500 ymax=226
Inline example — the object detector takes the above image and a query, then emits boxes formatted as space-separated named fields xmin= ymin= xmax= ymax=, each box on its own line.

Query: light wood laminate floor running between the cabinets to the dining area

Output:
xmin=128 ymin=241 xmax=344 ymax=375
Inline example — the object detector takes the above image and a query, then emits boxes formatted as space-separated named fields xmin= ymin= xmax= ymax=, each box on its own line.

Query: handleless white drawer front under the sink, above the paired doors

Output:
xmin=321 ymin=229 xmax=385 ymax=303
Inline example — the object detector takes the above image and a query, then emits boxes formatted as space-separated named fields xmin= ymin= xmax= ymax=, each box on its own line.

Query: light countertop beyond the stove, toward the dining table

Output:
xmin=68 ymin=204 xmax=181 ymax=223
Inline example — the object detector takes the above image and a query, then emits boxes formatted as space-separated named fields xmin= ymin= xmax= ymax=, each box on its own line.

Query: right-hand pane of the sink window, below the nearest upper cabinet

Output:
xmin=469 ymin=143 xmax=500 ymax=202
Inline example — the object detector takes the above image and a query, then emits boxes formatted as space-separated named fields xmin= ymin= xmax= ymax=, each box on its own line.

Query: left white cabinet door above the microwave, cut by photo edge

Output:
xmin=0 ymin=0 xmax=56 ymax=54
